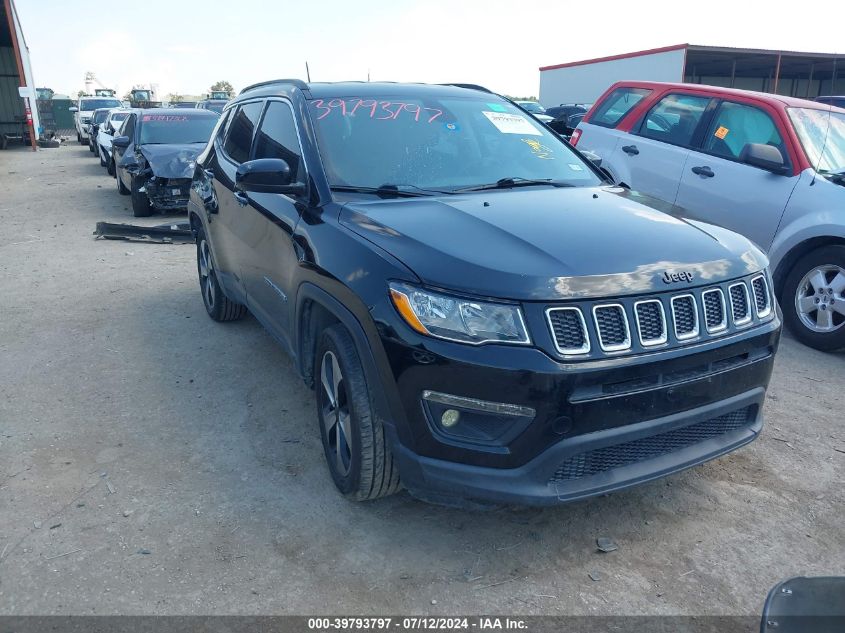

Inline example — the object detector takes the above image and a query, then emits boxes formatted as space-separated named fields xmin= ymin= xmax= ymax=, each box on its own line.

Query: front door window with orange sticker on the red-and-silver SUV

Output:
xmin=704 ymin=101 xmax=787 ymax=165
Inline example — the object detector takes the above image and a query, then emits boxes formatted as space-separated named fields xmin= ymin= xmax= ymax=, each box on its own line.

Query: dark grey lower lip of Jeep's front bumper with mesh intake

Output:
xmin=393 ymin=387 xmax=765 ymax=505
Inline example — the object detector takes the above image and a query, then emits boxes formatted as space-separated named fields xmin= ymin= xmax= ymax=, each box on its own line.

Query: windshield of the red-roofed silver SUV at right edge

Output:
xmin=789 ymin=108 xmax=845 ymax=173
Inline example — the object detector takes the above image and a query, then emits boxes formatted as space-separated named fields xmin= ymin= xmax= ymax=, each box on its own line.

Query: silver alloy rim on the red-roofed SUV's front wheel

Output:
xmin=795 ymin=264 xmax=845 ymax=334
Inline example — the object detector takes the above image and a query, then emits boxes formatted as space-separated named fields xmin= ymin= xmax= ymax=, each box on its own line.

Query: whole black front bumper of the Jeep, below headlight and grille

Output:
xmin=382 ymin=304 xmax=781 ymax=505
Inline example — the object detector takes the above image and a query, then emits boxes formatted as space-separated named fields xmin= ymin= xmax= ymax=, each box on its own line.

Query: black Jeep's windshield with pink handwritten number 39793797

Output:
xmin=309 ymin=95 xmax=601 ymax=190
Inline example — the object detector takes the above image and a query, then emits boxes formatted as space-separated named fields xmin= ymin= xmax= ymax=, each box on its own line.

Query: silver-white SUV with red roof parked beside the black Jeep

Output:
xmin=571 ymin=81 xmax=845 ymax=350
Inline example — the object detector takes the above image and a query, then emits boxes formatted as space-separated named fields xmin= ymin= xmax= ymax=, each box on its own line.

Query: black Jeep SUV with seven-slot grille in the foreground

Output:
xmin=188 ymin=80 xmax=781 ymax=504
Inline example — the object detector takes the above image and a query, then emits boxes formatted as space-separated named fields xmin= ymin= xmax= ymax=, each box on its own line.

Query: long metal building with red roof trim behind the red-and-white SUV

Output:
xmin=540 ymin=44 xmax=845 ymax=107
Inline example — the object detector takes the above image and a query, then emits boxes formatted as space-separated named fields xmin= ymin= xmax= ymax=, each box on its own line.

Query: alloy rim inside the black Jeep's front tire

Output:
xmin=320 ymin=352 xmax=352 ymax=477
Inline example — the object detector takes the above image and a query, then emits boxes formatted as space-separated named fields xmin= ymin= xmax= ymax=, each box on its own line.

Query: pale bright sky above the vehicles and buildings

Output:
xmin=15 ymin=0 xmax=845 ymax=97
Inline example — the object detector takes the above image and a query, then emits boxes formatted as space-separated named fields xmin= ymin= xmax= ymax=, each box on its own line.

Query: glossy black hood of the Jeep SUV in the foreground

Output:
xmin=340 ymin=187 xmax=767 ymax=300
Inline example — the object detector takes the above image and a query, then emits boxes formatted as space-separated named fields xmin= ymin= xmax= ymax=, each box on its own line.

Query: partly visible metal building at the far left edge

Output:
xmin=0 ymin=0 xmax=41 ymax=150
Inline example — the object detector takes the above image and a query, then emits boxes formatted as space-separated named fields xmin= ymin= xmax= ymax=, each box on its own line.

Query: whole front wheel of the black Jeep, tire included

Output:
xmin=314 ymin=324 xmax=402 ymax=501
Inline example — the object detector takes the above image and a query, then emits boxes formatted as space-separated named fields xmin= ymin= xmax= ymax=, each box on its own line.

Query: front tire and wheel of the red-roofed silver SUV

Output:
xmin=781 ymin=246 xmax=845 ymax=352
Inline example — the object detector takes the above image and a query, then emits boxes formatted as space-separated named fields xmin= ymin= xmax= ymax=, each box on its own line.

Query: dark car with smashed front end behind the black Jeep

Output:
xmin=112 ymin=108 xmax=218 ymax=217
